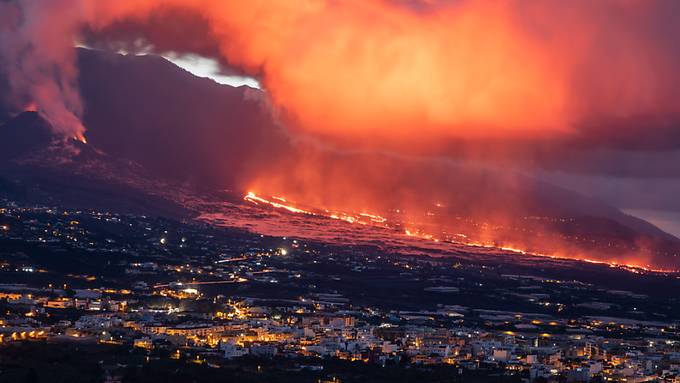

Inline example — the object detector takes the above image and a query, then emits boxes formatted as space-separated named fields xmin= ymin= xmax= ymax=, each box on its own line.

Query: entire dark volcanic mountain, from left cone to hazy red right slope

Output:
xmin=0 ymin=49 xmax=680 ymax=268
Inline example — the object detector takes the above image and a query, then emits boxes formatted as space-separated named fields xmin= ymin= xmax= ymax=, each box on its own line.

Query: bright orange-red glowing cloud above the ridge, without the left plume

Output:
xmin=85 ymin=0 xmax=680 ymax=141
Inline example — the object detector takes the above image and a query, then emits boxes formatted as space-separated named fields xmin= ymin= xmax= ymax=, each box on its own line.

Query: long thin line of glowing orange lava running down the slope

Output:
xmin=243 ymin=192 xmax=677 ymax=274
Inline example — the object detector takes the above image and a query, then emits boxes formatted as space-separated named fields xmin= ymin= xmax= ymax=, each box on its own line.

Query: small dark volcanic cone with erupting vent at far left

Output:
xmin=0 ymin=112 xmax=188 ymax=218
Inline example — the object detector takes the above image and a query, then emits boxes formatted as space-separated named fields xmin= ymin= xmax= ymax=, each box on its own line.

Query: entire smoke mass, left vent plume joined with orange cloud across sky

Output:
xmin=2 ymin=0 xmax=680 ymax=143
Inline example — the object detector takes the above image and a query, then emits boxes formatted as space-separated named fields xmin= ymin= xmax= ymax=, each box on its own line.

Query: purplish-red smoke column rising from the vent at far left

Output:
xmin=0 ymin=0 xmax=85 ymax=139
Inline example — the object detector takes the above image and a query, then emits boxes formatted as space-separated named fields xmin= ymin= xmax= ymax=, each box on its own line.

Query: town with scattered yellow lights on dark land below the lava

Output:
xmin=0 ymin=200 xmax=680 ymax=383
